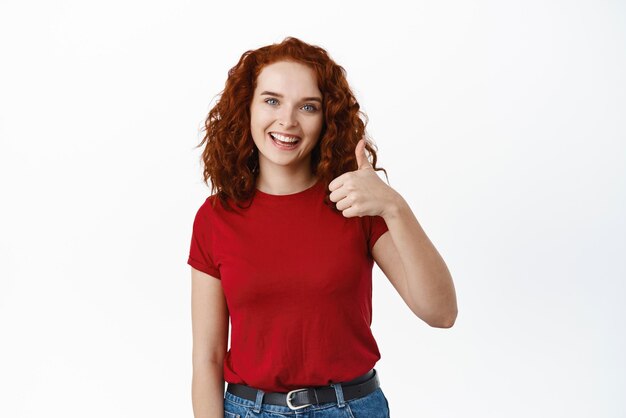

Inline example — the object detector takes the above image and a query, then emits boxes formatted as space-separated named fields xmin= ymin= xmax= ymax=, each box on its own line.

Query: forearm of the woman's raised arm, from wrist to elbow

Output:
xmin=383 ymin=194 xmax=457 ymax=328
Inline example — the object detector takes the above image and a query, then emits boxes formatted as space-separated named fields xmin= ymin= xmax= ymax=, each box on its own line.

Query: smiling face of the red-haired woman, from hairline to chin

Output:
xmin=250 ymin=61 xmax=323 ymax=177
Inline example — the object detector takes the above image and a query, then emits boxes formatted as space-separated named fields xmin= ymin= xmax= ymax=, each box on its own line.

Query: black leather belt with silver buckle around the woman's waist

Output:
xmin=226 ymin=369 xmax=380 ymax=410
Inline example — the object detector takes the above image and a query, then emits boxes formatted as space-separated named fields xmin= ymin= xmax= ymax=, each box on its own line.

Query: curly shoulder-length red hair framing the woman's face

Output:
xmin=197 ymin=37 xmax=387 ymax=210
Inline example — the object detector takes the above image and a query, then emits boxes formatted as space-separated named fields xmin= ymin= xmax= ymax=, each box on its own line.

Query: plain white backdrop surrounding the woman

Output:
xmin=0 ymin=0 xmax=626 ymax=418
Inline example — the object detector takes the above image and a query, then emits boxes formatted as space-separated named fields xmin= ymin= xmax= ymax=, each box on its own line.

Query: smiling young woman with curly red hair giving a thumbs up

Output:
xmin=188 ymin=37 xmax=457 ymax=418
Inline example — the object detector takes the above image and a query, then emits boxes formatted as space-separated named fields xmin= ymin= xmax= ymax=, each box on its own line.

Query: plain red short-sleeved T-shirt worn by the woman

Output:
xmin=187 ymin=181 xmax=387 ymax=392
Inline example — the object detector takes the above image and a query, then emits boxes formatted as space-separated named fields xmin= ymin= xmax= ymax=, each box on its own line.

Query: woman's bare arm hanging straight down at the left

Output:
xmin=191 ymin=267 xmax=229 ymax=418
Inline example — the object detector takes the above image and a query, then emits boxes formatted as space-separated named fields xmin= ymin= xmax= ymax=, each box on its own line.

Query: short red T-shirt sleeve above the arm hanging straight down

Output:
xmin=187 ymin=199 xmax=220 ymax=279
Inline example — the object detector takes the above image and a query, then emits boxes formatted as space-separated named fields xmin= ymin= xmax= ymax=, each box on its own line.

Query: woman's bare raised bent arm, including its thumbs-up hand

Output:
xmin=329 ymin=140 xmax=458 ymax=328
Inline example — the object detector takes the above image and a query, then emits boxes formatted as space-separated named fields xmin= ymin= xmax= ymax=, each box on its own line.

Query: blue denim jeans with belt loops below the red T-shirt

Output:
xmin=224 ymin=383 xmax=390 ymax=418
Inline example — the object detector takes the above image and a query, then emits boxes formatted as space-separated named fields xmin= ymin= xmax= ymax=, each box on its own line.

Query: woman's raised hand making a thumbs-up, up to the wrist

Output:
xmin=328 ymin=139 xmax=398 ymax=218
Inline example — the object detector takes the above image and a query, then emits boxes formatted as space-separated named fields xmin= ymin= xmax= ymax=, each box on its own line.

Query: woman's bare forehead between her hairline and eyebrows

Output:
xmin=255 ymin=61 xmax=320 ymax=97
